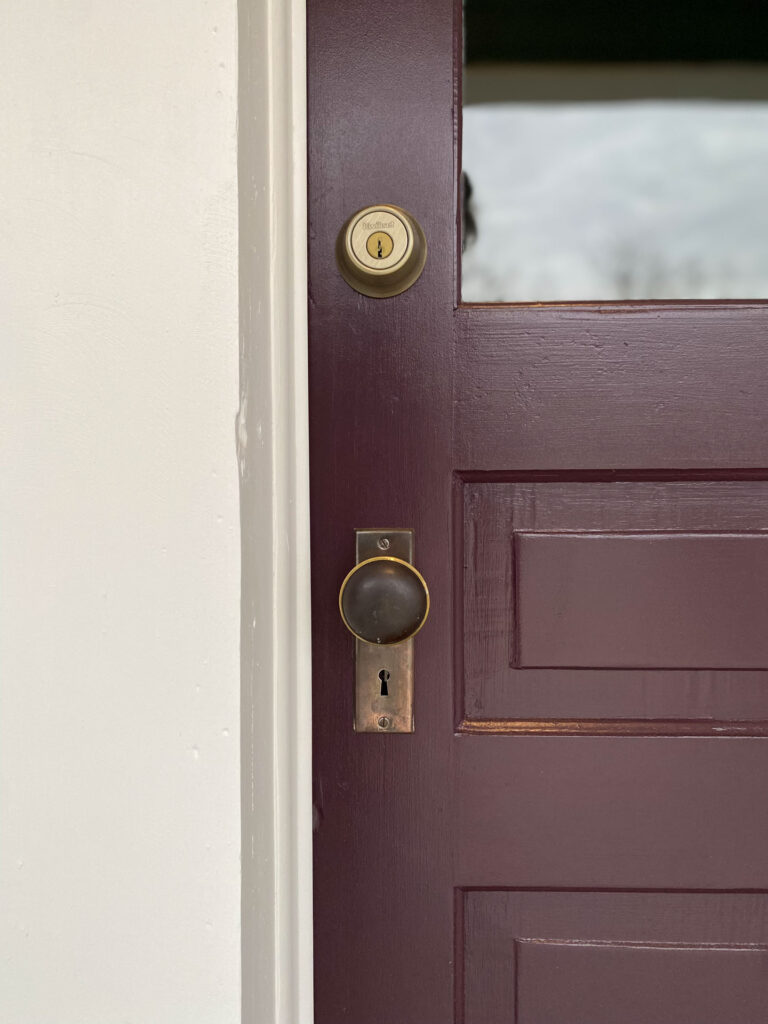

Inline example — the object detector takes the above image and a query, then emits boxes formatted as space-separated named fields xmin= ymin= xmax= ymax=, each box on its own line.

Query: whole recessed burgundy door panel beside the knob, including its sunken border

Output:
xmin=456 ymin=474 xmax=768 ymax=735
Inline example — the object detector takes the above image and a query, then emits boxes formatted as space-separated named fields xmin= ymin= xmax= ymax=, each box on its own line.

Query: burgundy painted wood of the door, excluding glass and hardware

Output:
xmin=308 ymin=0 xmax=768 ymax=1024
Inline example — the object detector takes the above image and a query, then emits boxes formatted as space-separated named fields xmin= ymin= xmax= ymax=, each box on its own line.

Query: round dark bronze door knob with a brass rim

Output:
xmin=339 ymin=555 xmax=429 ymax=644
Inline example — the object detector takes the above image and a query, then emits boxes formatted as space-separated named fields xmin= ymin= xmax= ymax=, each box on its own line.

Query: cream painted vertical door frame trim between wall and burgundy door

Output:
xmin=237 ymin=0 xmax=312 ymax=1024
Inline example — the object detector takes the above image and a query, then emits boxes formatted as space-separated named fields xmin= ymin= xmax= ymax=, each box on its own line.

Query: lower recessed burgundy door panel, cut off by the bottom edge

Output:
xmin=460 ymin=890 xmax=768 ymax=1024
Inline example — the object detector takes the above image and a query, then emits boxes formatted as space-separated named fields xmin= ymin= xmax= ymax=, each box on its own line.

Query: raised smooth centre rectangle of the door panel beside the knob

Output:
xmin=513 ymin=532 xmax=768 ymax=670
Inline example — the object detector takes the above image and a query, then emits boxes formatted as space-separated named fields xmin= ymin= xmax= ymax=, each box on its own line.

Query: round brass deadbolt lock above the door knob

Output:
xmin=336 ymin=203 xmax=427 ymax=299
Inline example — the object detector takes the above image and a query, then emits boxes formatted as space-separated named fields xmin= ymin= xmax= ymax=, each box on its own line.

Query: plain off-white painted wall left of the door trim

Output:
xmin=0 ymin=0 xmax=240 ymax=1024
